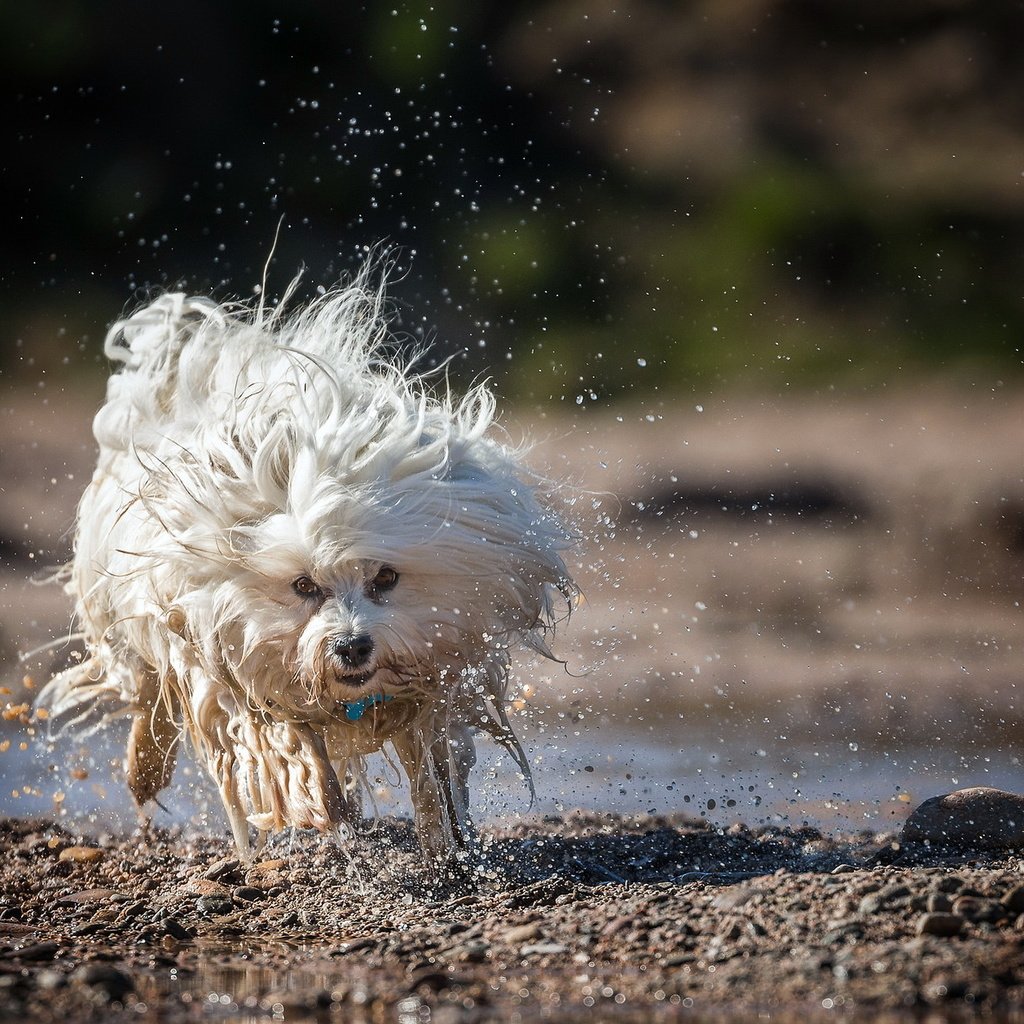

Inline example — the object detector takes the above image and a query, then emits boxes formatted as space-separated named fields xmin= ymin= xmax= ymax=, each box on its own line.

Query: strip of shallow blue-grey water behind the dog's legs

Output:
xmin=0 ymin=708 xmax=1024 ymax=833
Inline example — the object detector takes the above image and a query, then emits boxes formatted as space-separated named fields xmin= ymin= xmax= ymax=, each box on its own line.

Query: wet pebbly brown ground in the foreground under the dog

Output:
xmin=0 ymin=813 xmax=1024 ymax=1022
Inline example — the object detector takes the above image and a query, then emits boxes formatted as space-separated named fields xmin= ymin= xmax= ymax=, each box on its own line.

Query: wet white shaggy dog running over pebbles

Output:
xmin=41 ymin=273 xmax=574 ymax=858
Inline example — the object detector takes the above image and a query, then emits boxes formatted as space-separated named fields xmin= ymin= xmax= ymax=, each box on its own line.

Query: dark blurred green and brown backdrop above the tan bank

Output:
xmin=0 ymin=0 xmax=1024 ymax=402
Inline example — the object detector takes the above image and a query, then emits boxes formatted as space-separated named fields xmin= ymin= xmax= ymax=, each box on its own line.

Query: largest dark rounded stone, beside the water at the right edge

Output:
xmin=902 ymin=786 xmax=1024 ymax=849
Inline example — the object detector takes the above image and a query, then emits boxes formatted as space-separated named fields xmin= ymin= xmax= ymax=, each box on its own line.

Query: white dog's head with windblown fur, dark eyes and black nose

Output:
xmin=171 ymin=444 xmax=558 ymax=720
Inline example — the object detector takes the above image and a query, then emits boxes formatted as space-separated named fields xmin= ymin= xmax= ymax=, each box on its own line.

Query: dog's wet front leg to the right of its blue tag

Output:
xmin=391 ymin=723 xmax=476 ymax=863
